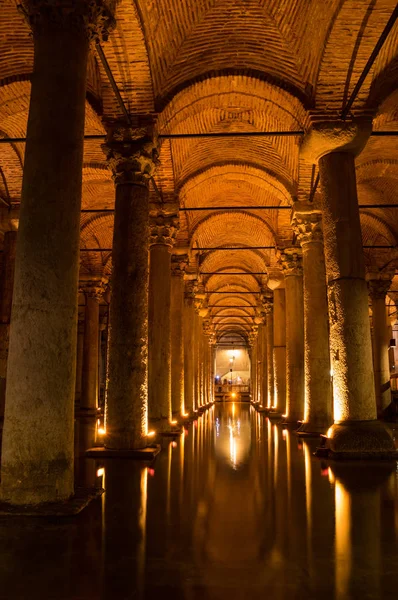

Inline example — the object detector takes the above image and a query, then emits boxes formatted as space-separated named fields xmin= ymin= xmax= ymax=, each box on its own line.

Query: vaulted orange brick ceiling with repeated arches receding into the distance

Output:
xmin=0 ymin=0 xmax=398 ymax=336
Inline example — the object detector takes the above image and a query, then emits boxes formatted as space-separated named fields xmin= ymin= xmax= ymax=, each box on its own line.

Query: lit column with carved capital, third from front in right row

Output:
xmin=281 ymin=247 xmax=304 ymax=423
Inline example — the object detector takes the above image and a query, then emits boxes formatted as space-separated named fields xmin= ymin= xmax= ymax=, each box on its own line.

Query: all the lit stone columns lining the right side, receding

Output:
xmin=251 ymin=123 xmax=394 ymax=457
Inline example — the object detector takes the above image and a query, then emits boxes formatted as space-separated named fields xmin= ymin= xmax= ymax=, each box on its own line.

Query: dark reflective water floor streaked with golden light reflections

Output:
xmin=0 ymin=403 xmax=398 ymax=600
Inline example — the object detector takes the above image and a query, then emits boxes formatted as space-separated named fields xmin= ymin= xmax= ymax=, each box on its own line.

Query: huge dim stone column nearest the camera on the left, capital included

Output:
xmin=1 ymin=0 xmax=113 ymax=505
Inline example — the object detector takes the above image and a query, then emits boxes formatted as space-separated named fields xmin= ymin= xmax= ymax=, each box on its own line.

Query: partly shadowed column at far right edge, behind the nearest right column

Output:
xmin=368 ymin=273 xmax=392 ymax=418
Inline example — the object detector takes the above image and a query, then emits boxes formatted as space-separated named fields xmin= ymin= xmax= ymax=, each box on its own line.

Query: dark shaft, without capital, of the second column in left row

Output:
xmin=105 ymin=183 xmax=149 ymax=450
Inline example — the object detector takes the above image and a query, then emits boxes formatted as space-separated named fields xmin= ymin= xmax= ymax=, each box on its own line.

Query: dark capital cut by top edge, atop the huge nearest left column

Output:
xmin=18 ymin=0 xmax=116 ymax=41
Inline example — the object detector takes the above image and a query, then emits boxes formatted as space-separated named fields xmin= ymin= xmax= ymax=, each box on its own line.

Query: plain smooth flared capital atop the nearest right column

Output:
xmin=300 ymin=117 xmax=372 ymax=163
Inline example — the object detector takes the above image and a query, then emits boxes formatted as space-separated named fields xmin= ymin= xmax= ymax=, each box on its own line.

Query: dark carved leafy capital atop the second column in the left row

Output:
xmin=101 ymin=115 xmax=158 ymax=186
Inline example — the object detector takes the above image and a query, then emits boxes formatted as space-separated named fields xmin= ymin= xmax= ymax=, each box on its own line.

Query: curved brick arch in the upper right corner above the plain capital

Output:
xmin=316 ymin=0 xmax=397 ymax=112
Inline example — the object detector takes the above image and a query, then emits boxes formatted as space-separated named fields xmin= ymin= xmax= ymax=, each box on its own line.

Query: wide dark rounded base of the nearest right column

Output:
xmin=315 ymin=421 xmax=398 ymax=460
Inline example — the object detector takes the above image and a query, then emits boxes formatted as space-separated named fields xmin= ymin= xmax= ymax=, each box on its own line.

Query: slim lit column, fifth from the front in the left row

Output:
xmin=184 ymin=281 xmax=196 ymax=416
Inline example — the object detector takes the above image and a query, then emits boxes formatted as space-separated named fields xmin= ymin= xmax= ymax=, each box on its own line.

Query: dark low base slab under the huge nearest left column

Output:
xmin=0 ymin=488 xmax=104 ymax=517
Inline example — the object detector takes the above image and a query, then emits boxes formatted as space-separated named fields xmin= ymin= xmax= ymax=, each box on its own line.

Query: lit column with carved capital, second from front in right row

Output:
xmin=292 ymin=202 xmax=333 ymax=433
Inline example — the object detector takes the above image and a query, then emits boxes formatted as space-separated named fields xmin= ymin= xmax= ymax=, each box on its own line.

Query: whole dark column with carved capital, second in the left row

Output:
xmin=104 ymin=118 xmax=157 ymax=452
